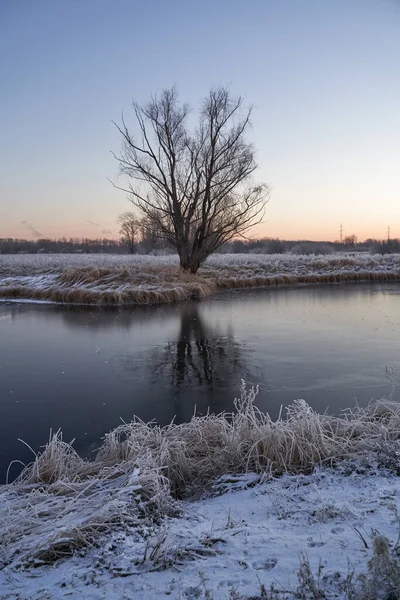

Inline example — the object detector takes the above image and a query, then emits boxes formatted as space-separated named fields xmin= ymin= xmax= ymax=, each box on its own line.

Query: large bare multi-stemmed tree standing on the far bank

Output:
xmin=112 ymin=88 xmax=269 ymax=273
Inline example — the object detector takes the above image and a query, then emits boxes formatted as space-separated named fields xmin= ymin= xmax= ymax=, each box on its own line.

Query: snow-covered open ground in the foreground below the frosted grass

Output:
xmin=0 ymin=460 xmax=400 ymax=600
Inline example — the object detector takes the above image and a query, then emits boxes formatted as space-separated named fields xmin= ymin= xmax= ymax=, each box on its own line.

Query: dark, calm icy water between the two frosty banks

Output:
xmin=0 ymin=283 xmax=400 ymax=480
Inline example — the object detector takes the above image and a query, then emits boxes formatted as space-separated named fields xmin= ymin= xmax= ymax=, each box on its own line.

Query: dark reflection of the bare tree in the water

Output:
xmin=59 ymin=301 xmax=259 ymax=422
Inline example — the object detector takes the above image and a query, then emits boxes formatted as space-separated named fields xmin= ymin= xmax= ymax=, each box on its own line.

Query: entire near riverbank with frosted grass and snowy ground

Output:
xmin=0 ymin=384 xmax=400 ymax=600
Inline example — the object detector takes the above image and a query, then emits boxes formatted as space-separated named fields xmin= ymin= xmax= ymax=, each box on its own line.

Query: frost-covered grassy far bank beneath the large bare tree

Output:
xmin=0 ymin=254 xmax=400 ymax=304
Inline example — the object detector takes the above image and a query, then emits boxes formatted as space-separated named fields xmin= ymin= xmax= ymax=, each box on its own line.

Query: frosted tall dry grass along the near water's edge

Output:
xmin=0 ymin=382 xmax=400 ymax=568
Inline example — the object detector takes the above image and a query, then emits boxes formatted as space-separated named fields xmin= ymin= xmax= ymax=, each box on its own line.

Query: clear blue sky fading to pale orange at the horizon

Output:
xmin=0 ymin=0 xmax=400 ymax=240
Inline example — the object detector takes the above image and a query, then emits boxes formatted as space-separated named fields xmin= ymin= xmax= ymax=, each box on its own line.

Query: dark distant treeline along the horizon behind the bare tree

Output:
xmin=0 ymin=236 xmax=400 ymax=254
